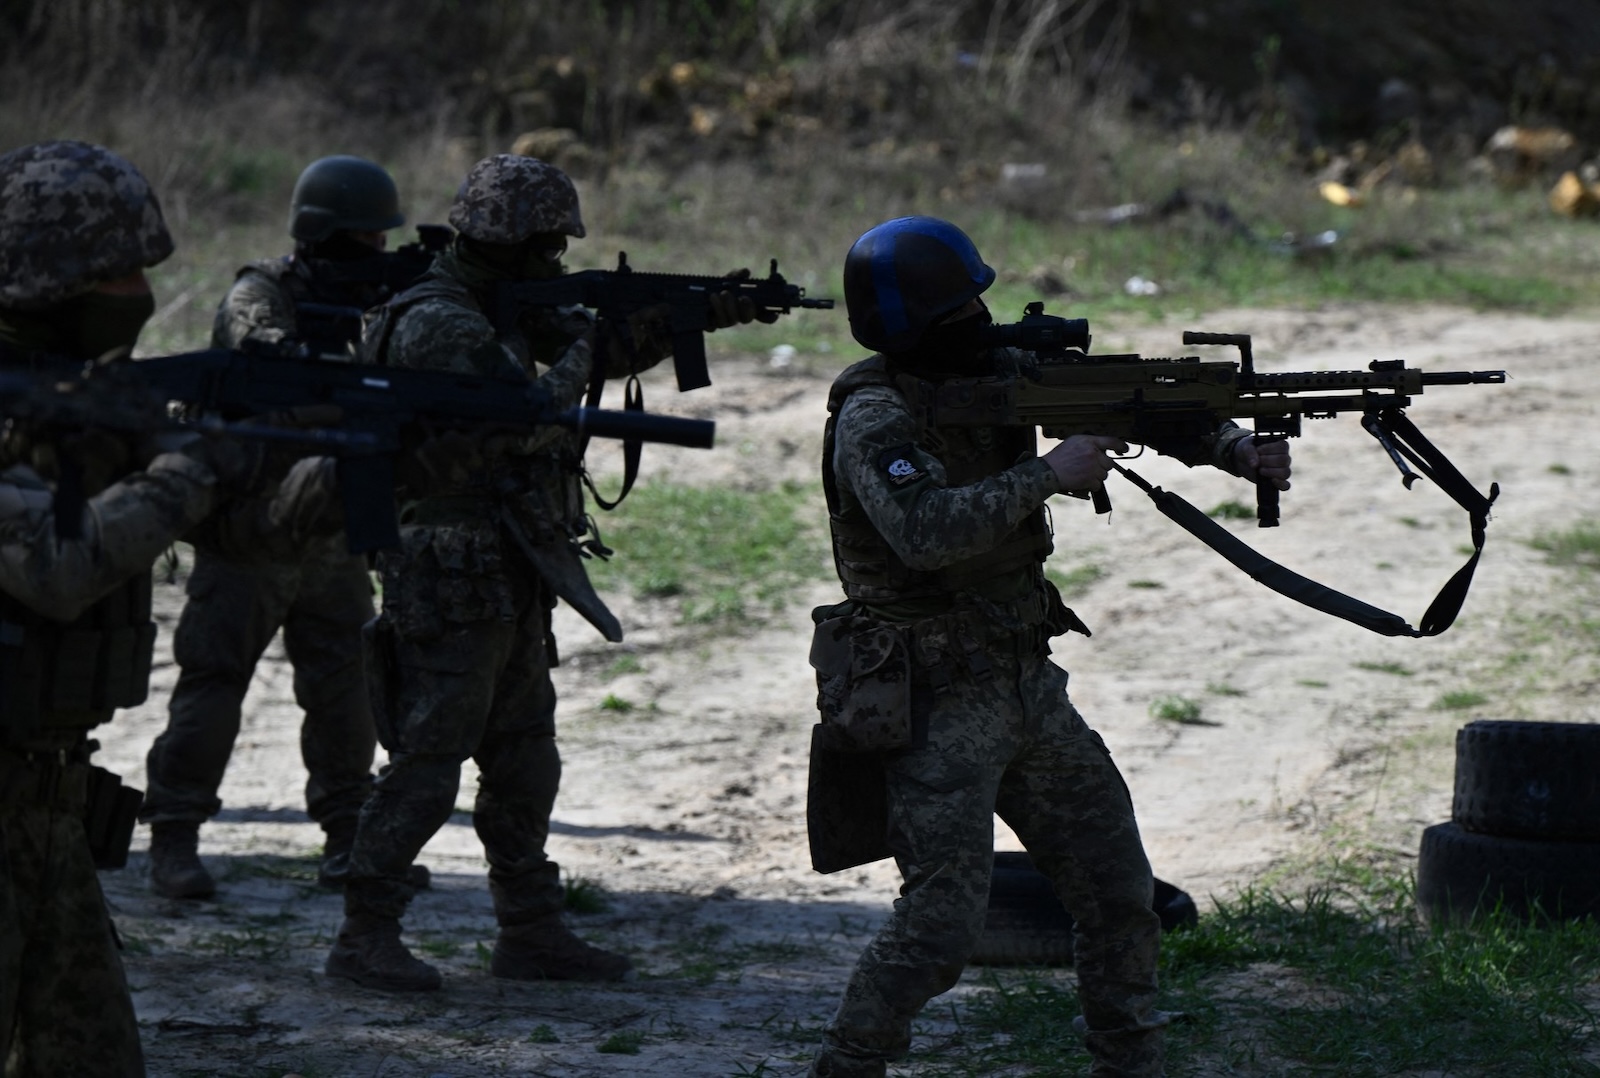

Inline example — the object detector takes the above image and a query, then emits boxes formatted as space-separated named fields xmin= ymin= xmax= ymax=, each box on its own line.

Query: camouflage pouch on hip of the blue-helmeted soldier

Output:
xmin=811 ymin=611 xmax=912 ymax=752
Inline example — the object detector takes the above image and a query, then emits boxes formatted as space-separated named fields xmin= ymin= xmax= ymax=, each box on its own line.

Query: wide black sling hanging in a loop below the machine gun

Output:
xmin=1112 ymin=408 xmax=1499 ymax=637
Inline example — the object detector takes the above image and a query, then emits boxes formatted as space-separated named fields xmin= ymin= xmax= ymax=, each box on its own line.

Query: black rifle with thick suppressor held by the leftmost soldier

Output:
xmin=0 ymin=345 xmax=715 ymax=553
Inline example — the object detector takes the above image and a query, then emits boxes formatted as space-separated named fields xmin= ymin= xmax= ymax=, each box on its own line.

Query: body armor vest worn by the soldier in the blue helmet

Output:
xmin=822 ymin=355 xmax=1054 ymax=603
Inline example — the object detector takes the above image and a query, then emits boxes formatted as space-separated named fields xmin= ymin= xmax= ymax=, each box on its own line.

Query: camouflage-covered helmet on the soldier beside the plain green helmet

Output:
xmin=450 ymin=154 xmax=584 ymax=243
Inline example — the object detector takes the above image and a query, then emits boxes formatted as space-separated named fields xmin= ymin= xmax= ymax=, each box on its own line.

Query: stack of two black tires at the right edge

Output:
xmin=1416 ymin=721 xmax=1600 ymax=921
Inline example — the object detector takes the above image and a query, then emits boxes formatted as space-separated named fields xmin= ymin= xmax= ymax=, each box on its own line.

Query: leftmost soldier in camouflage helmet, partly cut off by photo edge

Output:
xmin=0 ymin=142 xmax=340 ymax=1078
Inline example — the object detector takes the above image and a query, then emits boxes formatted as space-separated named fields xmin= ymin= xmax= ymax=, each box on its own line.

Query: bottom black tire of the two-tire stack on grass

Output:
xmin=1416 ymin=824 xmax=1600 ymax=921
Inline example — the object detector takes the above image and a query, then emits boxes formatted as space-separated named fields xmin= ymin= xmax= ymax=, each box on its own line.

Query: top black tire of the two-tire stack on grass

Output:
xmin=1450 ymin=721 xmax=1600 ymax=843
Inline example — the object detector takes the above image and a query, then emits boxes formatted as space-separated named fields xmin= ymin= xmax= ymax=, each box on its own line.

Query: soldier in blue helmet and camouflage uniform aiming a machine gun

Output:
xmin=810 ymin=218 xmax=1290 ymax=1078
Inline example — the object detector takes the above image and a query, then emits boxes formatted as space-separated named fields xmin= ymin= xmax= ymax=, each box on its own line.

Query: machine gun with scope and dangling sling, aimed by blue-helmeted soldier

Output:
xmin=934 ymin=302 xmax=1506 ymax=635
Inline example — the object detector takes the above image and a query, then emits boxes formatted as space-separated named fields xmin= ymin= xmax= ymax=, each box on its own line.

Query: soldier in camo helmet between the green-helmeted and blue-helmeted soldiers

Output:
xmin=326 ymin=154 xmax=754 ymax=992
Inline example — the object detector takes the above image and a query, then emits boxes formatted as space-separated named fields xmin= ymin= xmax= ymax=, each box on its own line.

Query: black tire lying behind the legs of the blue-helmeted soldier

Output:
xmin=970 ymin=851 xmax=1198 ymax=966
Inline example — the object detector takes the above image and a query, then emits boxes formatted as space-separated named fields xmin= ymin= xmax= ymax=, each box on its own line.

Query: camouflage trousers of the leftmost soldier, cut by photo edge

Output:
xmin=0 ymin=793 xmax=144 ymax=1078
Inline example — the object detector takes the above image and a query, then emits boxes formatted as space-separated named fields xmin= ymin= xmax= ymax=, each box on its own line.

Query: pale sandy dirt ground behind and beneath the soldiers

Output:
xmin=90 ymin=307 xmax=1600 ymax=1078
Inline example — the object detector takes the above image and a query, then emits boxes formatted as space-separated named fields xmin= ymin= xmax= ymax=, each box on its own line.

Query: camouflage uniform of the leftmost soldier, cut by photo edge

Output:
xmin=0 ymin=454 xmax=233 ymax=1078
